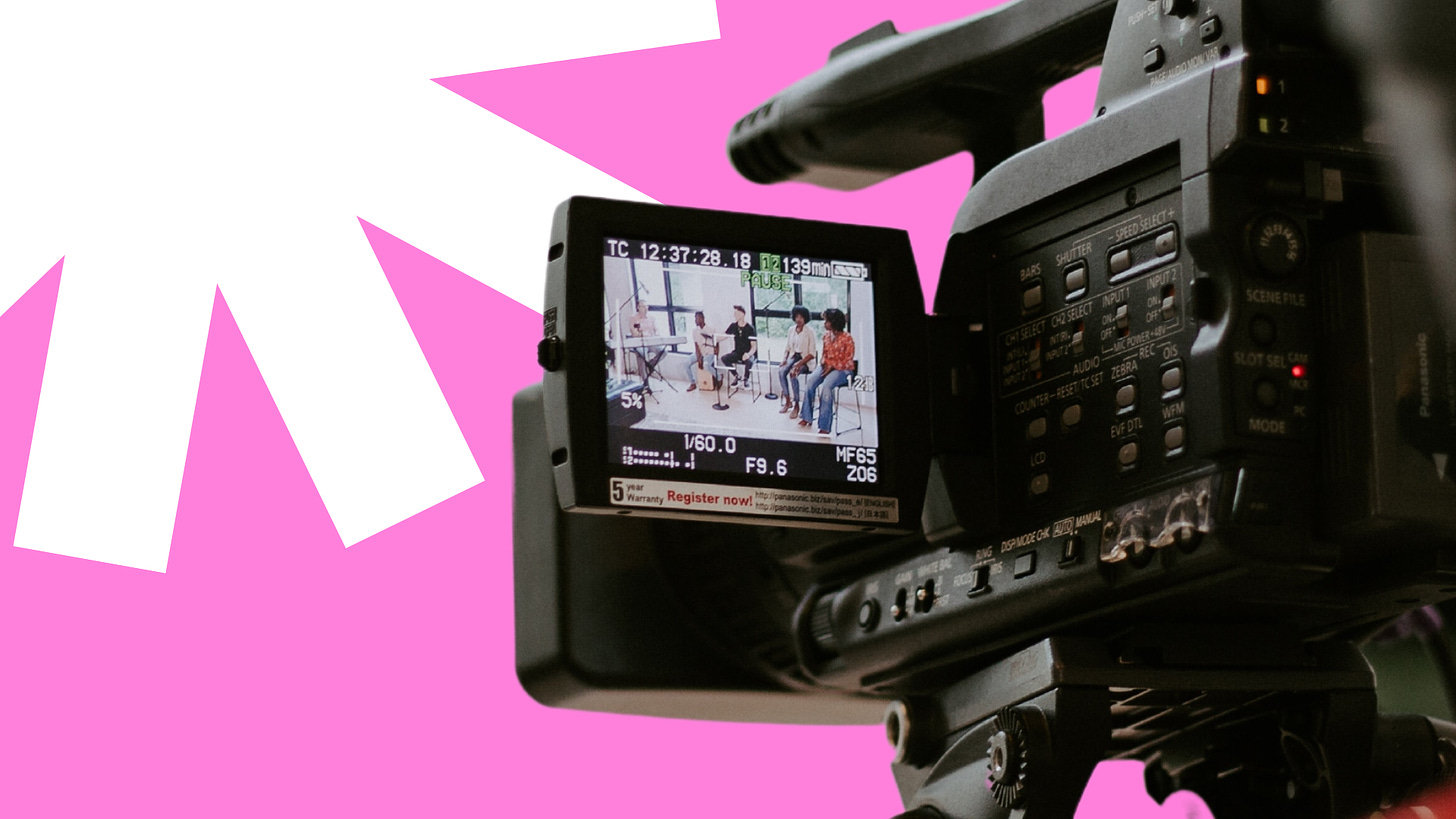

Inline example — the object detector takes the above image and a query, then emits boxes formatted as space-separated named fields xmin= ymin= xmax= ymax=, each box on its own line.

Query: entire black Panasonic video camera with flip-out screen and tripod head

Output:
xmin=515 ymin=0 xmax=1456 ymax=818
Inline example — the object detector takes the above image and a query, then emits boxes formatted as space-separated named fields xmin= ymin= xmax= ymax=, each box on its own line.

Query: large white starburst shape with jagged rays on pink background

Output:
xmin=0 ymin=0 xmax=718 ymax=570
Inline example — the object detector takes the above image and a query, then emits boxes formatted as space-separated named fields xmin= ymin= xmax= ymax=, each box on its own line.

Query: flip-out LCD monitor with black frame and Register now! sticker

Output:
xmin=542 ymin=197 xmax=929 ymax=532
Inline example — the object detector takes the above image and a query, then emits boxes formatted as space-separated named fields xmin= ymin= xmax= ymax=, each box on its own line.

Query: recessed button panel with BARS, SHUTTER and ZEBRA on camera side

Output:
xmin=992 ymin=185 xmax=1197 ymax=517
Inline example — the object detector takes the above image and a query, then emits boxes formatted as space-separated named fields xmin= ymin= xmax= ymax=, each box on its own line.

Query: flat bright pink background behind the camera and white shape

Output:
xmin=0 ymin=0 xmax=1205 ymax=819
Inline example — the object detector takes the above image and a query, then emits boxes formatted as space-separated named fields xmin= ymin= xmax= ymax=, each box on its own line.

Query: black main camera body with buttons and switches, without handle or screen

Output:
xmin=802 ymin=3 xmax=1456 ymax=691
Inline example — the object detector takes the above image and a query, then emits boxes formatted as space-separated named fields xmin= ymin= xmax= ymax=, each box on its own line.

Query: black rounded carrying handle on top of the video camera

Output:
xmin=728 ymin=0 xmax=1117 ymax=189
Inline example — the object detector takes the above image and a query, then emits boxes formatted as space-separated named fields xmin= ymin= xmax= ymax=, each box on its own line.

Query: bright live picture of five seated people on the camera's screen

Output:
xmin=603 ymin=240 xmax=878 ymax=447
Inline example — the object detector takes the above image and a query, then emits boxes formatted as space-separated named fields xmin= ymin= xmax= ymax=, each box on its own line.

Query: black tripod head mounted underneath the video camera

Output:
xmin=885 ymin=627 xmax=1456 ymax=819
